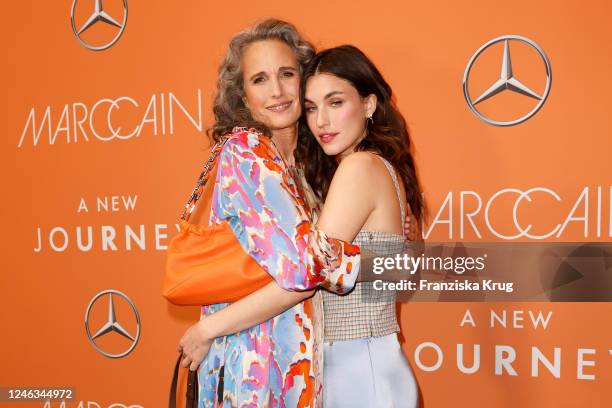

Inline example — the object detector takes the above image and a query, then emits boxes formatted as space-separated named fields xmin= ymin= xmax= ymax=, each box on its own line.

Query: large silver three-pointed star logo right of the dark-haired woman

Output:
xmin=463 ymin=35 xmax=552 ymax=126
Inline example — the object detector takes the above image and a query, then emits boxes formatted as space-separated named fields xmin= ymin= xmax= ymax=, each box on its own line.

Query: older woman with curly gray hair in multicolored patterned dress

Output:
xmin=179 ymin=20 xmax=359 ymax=407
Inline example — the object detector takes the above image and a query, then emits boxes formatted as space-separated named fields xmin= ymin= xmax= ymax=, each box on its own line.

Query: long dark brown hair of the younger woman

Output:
xmin=295 ymin=45 xmax=423 ymax=224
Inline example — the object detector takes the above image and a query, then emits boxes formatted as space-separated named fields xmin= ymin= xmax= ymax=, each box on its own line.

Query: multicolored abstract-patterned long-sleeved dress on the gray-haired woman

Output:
xmin=198 ymin=128 xmax=360 ymax=408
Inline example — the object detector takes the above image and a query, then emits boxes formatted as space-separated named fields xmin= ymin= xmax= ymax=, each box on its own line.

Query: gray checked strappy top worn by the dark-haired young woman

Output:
xmin=321 ymin=155 xmax=405 ymax=342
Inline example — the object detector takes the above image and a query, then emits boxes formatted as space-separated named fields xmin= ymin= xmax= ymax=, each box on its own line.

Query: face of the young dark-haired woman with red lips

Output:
xmin=304 ymin=73 xmax=376 ymax=160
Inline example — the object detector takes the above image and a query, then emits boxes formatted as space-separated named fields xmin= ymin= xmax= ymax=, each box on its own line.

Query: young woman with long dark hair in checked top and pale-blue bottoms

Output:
xmin=297 ymin=45 xmax=423 ymax=408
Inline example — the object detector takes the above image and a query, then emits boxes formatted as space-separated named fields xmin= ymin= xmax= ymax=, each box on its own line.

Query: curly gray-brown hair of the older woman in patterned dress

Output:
xmin=209 ymin=19 xmax=315 ymax=142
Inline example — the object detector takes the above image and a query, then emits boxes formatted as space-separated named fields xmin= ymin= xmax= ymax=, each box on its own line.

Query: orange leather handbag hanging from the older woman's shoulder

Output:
xmin=163 ymin=138 xmax=272 ymax=305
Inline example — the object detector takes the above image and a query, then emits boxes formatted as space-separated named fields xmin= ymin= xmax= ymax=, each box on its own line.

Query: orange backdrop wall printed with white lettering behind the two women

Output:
xmin=0 ymin=0 xmax=612 ymax=408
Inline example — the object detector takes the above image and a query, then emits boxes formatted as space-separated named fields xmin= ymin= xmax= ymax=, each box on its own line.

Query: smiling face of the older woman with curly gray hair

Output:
xmin=241 ymin=40 xmax=301 ymax=131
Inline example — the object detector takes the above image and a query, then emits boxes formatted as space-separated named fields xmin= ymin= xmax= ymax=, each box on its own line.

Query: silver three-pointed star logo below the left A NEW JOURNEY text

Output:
xmin=85 ymin=289 xmax=140 ymax=358
